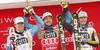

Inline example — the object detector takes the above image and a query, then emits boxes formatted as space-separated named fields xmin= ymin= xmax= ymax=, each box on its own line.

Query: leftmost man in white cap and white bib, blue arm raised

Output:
xmin=6 ymin=7 xmax=42 ymax=50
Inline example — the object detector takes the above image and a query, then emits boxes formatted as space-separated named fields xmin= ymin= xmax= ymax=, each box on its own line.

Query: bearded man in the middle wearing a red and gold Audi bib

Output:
xmin=24 ymin=1 xmax=71 ymax=50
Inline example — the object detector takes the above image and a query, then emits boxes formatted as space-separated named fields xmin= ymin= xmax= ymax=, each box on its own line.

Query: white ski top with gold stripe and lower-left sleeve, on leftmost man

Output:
xmin=6 ymin=30 xmax=32 ymax=50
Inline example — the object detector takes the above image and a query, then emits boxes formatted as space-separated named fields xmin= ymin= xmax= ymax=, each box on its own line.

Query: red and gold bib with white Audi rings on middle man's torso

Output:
xmin=39 ymin=26 xmax=60 ymax=50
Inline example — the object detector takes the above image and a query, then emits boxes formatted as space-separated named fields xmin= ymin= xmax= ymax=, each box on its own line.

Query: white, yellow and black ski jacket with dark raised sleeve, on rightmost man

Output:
xmin=61 ymin=8 xmax=99 ymax=50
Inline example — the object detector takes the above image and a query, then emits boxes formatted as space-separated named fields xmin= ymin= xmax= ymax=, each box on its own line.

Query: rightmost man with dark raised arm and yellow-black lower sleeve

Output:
xmin=61 ymin=5 xmax=99 ymax=50
